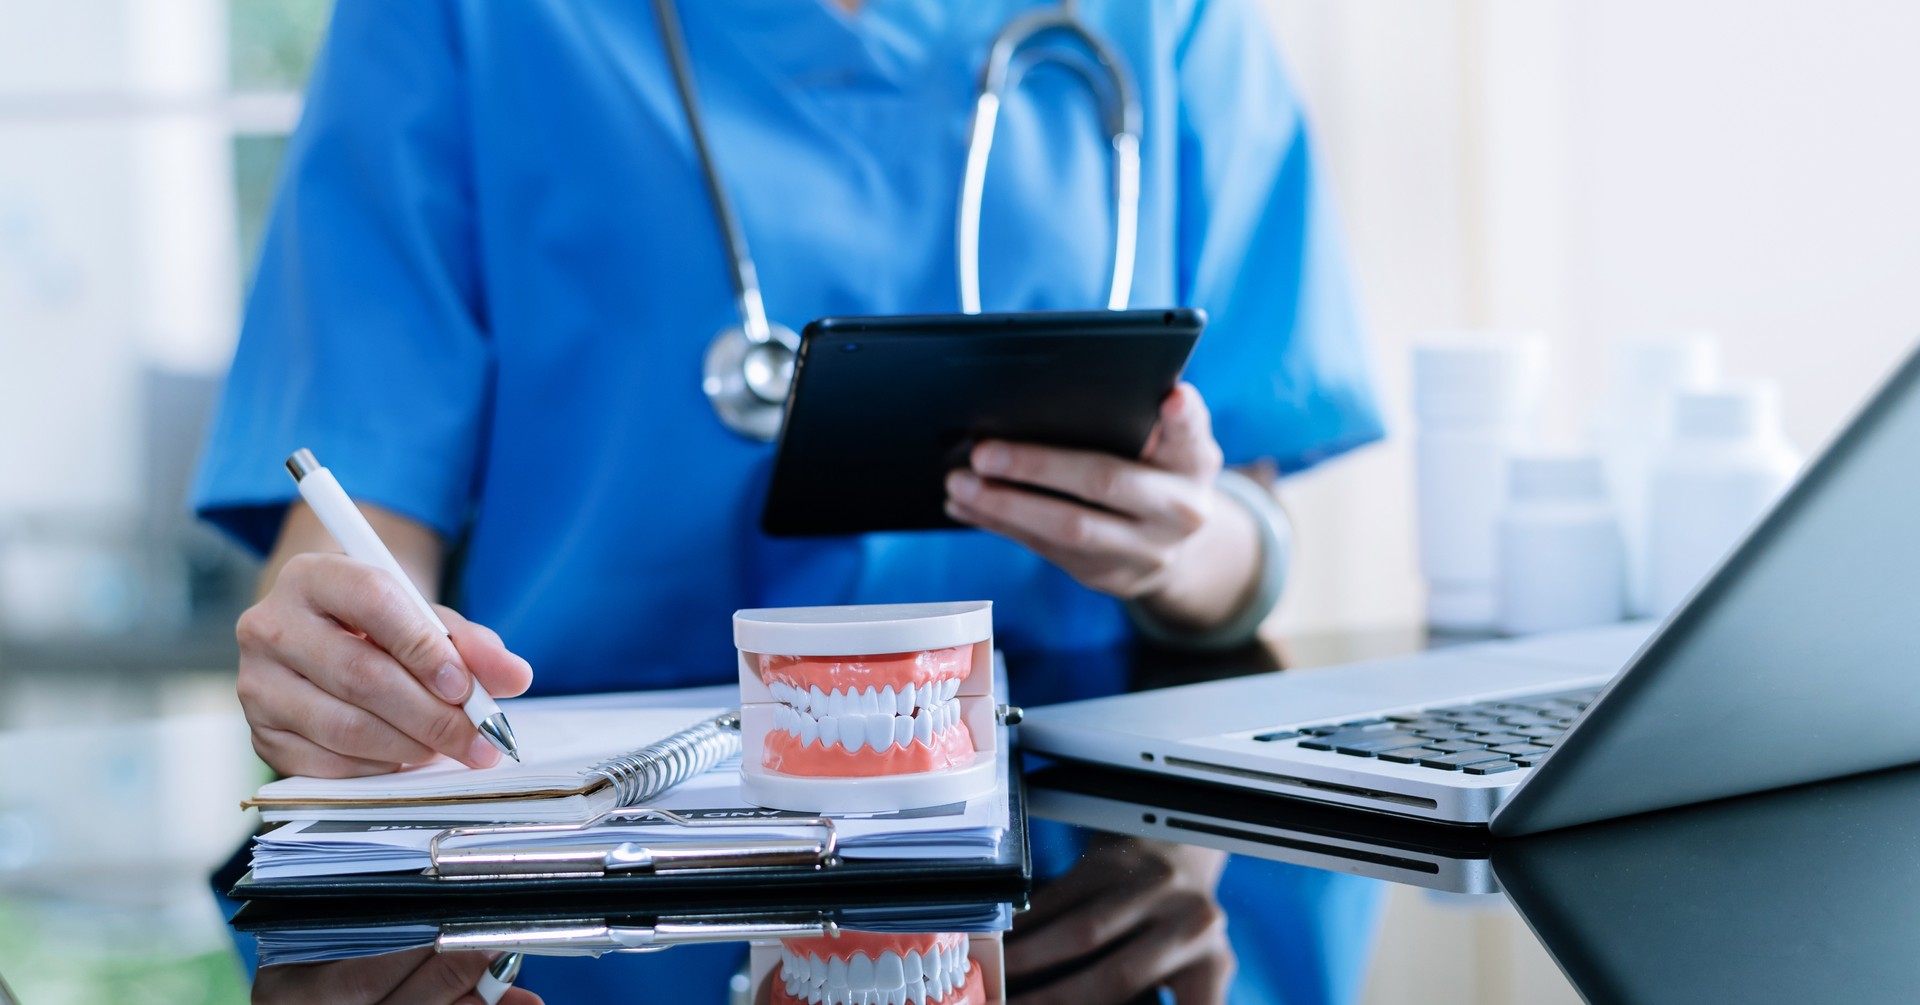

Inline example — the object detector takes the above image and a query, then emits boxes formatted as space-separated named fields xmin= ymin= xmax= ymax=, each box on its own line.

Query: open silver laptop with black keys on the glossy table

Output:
xmin=1020 ymin=342 xmax=1920 ymax=834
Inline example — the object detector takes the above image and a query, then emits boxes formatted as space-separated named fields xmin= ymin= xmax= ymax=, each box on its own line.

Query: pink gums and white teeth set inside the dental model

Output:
xmin=758 ymin=646 xmax=977 ymax=778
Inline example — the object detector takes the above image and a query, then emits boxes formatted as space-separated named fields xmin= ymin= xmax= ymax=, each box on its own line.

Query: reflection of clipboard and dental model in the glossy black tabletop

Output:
xmin=234 ymin=903 xmax=1014 ymax=1005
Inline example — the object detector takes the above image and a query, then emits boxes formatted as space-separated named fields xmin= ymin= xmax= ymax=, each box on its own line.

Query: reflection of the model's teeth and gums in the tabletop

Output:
xmin=768 ymin=932 xmax=987 ymax=1005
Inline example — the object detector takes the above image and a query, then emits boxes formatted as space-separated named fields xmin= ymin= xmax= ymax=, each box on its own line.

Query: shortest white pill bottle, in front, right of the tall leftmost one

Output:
xmin=1498 ymin=453 xmax=1626 ymax=636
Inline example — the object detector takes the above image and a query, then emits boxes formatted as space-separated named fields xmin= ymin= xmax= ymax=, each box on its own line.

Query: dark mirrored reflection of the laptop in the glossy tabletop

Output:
xmin=1029 ymin=765 xmax=1920 ymax=1003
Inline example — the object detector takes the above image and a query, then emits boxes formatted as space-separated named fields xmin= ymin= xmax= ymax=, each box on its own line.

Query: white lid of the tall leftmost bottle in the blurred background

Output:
xmin=1413 ymin=334 xmax=1548 ymax=425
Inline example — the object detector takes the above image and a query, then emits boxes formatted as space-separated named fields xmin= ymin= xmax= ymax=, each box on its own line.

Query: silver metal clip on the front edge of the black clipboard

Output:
xmin=426 ymin=809 xmax=839 ymax=880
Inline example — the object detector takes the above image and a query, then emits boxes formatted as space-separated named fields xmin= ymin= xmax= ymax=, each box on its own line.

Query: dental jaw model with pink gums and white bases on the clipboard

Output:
xmin=733 ymin=601 xmax=1000 ymax=813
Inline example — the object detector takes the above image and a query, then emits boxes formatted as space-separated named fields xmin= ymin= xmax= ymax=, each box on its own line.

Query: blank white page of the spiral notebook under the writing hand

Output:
xmin=255 ymin=705 xmax=726 ymax=801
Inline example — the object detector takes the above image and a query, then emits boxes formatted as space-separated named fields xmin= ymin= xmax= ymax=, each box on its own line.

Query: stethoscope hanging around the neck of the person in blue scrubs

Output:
xmin=653 ymin=0 xmax=1140 ymax=440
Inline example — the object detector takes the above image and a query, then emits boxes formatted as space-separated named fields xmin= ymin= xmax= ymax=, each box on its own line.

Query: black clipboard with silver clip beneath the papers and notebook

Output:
xmin=227 ymin=741 xmax=1033 ymax=913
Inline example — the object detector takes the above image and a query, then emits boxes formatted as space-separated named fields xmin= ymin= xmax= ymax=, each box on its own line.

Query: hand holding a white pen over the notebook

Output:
xmin=236 ymin=452 xmax=532 ymax=776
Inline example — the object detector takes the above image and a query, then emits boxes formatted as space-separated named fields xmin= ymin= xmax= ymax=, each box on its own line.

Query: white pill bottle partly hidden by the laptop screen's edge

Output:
xmin=1647 ymin=382 xmax=1801 ymax=615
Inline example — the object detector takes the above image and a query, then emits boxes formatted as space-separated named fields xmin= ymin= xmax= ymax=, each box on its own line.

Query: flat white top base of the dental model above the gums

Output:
xmin=733 ymin=600 xmax=993 ymax=655
